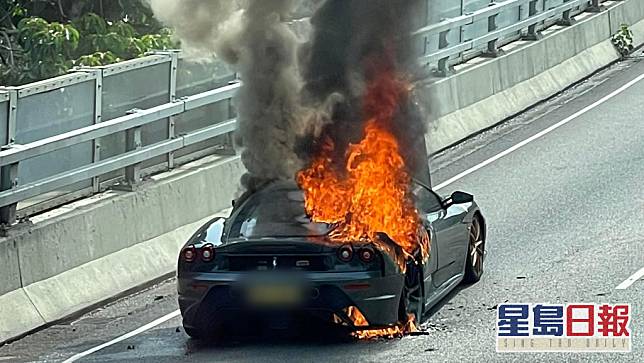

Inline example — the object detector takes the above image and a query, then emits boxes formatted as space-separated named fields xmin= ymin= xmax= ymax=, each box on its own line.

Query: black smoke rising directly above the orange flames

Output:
xmin=300 ymin=0 xmax=429 ymax=182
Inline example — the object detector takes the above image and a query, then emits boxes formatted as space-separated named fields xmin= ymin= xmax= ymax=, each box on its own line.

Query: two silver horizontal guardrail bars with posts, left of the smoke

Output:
xmin=0 ymin=78 xmax=239 ymax=223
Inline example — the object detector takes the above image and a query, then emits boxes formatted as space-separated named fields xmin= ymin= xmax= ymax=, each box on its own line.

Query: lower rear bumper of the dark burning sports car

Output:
xmin=178 ymin=272 xmax=403 ymax=328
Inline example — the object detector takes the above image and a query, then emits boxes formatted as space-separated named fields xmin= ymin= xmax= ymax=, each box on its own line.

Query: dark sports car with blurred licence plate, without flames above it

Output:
xmin=177 ymin=181 xmax=486 ymax=338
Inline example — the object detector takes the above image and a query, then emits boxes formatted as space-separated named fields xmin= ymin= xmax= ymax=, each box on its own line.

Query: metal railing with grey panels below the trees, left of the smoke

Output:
xmin=0 ymin=52 xmax=239 ymax=225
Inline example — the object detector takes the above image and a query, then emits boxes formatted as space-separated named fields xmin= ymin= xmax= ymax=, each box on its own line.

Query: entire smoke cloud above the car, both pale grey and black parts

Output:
xmin=148 ymin=0 xmax=429 ymax=189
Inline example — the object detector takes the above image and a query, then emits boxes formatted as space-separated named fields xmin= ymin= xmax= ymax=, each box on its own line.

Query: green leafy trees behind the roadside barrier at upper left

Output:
xmin=0 ymin=0 xmax=177 ymax=85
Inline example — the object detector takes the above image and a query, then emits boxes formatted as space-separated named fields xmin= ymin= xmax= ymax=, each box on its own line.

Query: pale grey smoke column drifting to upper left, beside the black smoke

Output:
xmin=151 ymin=0 xmax=308 ymax=189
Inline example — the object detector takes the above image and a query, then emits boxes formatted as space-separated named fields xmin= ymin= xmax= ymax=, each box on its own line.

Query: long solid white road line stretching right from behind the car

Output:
xmin=434 ymin=74 xmax=644 ymax=190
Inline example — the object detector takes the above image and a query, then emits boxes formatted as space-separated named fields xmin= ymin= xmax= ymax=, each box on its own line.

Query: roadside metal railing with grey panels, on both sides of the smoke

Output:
xmin=0 ymin=0 xmax=602 ymax=225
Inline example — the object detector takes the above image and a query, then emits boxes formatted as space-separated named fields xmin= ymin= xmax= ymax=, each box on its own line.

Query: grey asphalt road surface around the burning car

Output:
xmin=0 ymin=55 xmax=644 ymax=363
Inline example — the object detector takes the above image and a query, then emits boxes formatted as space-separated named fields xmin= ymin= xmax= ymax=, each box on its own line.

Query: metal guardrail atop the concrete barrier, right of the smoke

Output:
xmin=412 ymin=0 xmax=605 ymax=76
